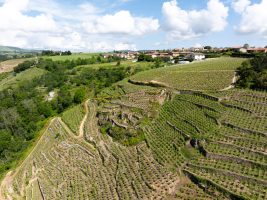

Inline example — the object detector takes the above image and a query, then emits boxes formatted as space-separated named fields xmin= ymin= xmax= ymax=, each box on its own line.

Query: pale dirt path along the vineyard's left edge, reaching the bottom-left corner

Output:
xmin=0 ymin=118 xmax=57 ymax=200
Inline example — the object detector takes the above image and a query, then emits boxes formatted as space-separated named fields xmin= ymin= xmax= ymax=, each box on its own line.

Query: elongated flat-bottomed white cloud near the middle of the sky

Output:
xmin=83 ymin=10 xmax=159 ymax=35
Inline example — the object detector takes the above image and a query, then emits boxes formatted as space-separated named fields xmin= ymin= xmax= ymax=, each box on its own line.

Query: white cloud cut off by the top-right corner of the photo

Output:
xmin=236 ymin=0 xmax=267 ymax=38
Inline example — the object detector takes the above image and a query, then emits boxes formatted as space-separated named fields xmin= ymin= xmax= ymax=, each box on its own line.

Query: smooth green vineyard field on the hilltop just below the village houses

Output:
xmin=131 ymin=58 xmax=244 ymax=90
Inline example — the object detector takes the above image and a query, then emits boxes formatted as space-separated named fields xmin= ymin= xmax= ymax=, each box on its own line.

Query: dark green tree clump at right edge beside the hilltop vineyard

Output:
xmin=237 ymin=56 xmax=267 ymax=90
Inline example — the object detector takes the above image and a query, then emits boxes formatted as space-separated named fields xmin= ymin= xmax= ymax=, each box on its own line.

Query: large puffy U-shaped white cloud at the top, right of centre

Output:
xmin=162 ymin=0 xmax=228 ymax=39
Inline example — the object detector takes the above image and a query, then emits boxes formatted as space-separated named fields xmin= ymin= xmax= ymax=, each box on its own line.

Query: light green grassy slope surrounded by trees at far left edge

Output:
xmin=0 ymin=67 xmax=45 ymax=90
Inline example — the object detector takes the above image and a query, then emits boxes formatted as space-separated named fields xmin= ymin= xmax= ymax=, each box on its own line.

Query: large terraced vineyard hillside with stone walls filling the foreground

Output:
xmin=0 ymin=59 xmax=267 ymax=200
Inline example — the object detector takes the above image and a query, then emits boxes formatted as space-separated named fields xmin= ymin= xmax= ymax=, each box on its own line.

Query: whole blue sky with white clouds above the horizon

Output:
xmin=0 ymin=0 xmax=267 ymax=52
